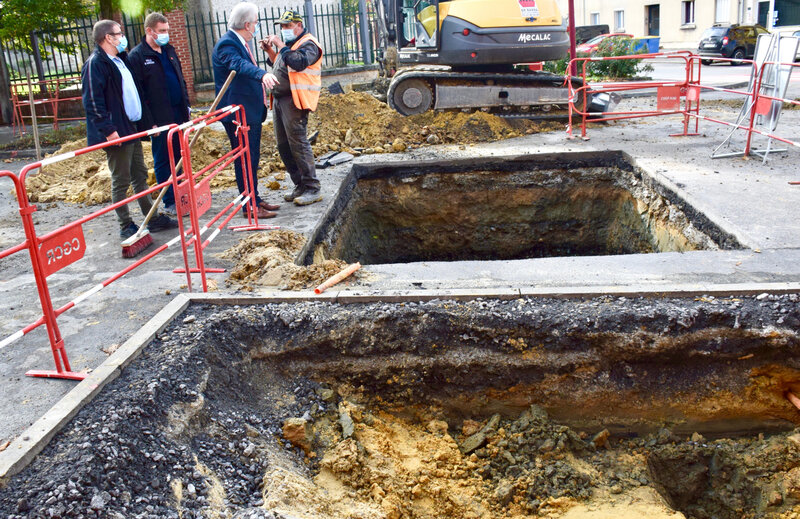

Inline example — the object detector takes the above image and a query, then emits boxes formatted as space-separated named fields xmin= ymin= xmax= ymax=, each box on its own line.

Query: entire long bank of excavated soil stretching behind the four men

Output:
xmin=21 ymin=92 xmax=563 ymax=205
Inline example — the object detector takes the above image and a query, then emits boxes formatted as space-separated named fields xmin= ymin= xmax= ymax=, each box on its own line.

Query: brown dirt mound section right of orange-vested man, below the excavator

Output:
xmin=309 ymin=92 xmax=563 ymax=154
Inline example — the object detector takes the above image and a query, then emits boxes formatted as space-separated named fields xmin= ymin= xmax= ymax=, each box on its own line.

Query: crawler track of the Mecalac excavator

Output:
xmin=387 ymin=65 xmax=582 ymax=121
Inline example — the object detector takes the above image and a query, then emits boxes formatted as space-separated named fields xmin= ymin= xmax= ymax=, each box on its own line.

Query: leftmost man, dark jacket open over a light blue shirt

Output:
xmin=81 ymin=20 xmax=178 ymax=240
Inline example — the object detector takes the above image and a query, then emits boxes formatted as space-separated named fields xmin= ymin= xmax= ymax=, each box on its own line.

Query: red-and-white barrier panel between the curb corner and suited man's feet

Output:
xmin=168 ymin=106 xmax=279 ymax=292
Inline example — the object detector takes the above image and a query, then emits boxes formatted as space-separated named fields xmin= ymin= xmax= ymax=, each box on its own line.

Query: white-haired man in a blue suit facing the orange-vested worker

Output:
xmin=212 ymin=2 xmax=280 ymax=218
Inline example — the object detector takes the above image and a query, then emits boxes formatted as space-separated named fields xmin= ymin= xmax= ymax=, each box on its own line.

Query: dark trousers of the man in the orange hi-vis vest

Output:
xmin=272 ymin=96 xmax=319 ymax=191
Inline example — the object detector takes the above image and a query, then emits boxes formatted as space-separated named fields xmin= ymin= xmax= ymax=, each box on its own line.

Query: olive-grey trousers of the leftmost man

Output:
xmin=103 ymin=139 xmax=153 ymax=229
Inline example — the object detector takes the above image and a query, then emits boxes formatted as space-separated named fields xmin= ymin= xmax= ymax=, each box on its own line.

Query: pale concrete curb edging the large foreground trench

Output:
xmin=0 ymin=282 xmax=800 ymax=488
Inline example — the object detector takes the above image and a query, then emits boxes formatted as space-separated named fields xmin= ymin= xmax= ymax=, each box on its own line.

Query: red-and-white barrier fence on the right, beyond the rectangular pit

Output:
xmin=566 ymin=52 xmax=800 ymax=169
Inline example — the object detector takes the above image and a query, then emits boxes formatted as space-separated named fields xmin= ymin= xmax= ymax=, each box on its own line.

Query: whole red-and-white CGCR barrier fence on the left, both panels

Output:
xmin=0 ymin=106 xmax=276 ymax=380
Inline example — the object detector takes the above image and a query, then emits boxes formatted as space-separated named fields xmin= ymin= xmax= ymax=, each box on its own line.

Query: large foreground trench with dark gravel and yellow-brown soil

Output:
xmin=0 ymin=294 xmax=800 ymax=519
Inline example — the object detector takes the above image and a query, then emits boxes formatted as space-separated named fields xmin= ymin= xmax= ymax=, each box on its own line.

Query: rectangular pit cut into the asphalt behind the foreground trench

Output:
xmin=302 ymin=151 xmax=739 ymax=264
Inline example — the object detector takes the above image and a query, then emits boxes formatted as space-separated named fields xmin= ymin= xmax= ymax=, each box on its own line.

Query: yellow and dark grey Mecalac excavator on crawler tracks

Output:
xmin=373 ymin=0 xmax=581 ymax=119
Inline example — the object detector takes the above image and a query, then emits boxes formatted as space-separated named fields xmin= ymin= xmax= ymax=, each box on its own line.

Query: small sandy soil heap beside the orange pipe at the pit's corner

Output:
xmin=220 ymin=230 xmax=354 ymax=290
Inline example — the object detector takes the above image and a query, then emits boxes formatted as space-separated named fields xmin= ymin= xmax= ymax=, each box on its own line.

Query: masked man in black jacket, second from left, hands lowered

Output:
xmin=128 ymin=13 xmax=189 ymax=215
